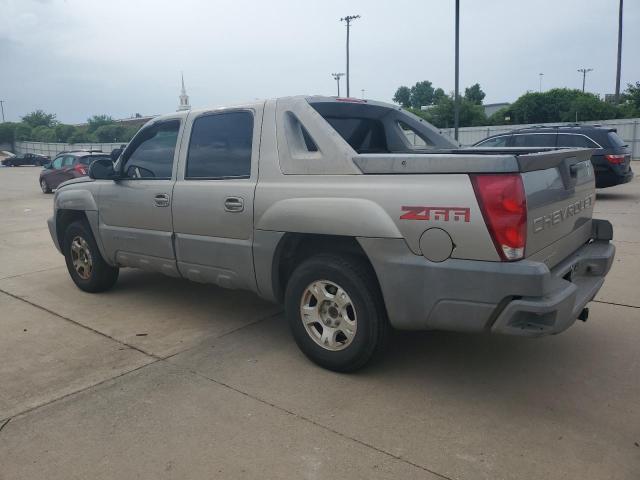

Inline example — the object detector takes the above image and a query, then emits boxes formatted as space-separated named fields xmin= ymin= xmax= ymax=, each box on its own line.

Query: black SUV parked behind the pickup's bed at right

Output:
xmin=473 ymin=125 xmax=633 ymax=188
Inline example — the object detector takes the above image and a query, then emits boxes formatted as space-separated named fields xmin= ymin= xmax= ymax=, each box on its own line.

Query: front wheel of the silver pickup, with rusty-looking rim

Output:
xmin=62 ymin=221 xmax=120 ymax=293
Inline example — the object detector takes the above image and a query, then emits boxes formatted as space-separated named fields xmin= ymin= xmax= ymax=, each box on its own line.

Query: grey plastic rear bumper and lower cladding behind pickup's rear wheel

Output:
xmin=359 ymin=220 xmax=615 ymax=336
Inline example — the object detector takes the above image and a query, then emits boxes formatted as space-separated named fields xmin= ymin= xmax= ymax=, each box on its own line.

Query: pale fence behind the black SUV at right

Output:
xmin=440 ymin=118 xmax=640 ymax=160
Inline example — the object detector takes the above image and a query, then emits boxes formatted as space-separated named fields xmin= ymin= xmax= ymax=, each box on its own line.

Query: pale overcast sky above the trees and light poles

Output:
xmin=0 ymin=0 xmax=640 ymax=123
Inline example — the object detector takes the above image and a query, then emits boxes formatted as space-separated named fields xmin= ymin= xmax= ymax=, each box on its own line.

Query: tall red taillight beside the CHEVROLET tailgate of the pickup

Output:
xmin=471 ymin=174 xmax=527 ymax=261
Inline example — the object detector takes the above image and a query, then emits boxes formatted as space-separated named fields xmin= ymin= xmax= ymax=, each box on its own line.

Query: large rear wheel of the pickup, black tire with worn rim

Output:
xmin=285 ymin=254 xmax=390 ymax=372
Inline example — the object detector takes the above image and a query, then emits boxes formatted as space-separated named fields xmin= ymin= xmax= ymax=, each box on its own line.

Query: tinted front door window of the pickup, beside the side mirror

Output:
xmin=122 ymin=120 xmax=180 ymax=180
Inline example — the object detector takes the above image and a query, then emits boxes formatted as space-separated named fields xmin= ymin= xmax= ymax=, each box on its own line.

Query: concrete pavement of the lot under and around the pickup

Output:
xmin=0 ymin=167 xmax=640 ymax=480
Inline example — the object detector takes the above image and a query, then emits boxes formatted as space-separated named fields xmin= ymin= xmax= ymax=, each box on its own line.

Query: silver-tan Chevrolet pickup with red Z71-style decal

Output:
xmin=48 ymin=97 xmax=615 ymax=371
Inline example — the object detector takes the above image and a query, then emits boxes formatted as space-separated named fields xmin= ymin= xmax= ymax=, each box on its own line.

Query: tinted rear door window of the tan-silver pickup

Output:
xmin=185 ymin=111 xmax=253 ymax=179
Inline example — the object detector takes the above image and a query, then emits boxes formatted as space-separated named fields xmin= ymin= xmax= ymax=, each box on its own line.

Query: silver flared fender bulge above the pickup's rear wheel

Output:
xmin=256 ymin=198 xmax=402 ymax=238
